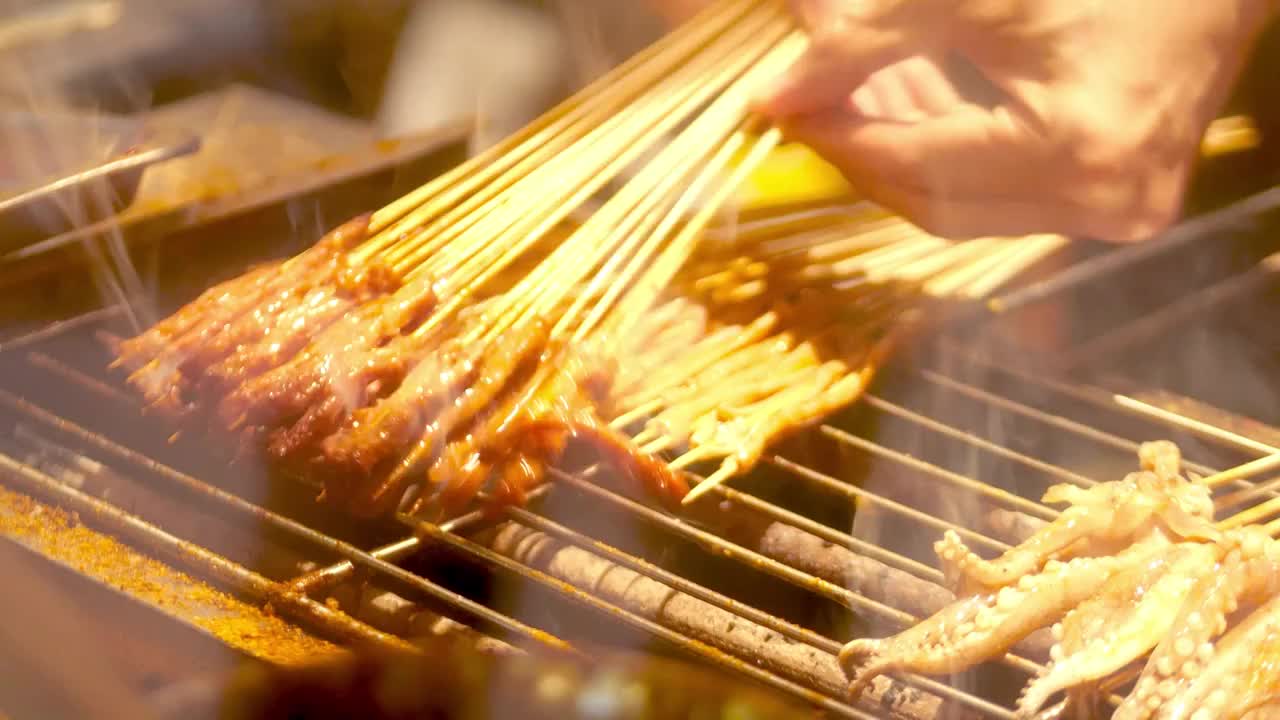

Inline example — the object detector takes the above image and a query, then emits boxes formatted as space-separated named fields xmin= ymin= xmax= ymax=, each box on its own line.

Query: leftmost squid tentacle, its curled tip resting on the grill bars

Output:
xmin=840 ymin=548 xmax=1149 ymax=697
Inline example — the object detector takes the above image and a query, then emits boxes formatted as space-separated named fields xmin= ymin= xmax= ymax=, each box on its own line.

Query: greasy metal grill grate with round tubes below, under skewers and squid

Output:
xmin=0 ymin=283 xmax=1280 ymax=717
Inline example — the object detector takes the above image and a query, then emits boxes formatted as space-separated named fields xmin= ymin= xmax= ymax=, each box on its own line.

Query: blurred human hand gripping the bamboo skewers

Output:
xmin=759 ymin=0 xmax=1280 ymax=241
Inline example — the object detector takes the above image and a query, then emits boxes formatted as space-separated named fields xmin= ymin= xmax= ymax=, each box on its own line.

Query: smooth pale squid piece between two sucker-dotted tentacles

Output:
xmin=1018 ymin=543 xmax=1221 ymax=717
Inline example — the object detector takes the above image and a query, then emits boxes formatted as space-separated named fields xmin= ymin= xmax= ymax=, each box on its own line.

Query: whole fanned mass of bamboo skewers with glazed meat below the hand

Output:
xmin=107 ymin=0 xmax=1061 ymax=514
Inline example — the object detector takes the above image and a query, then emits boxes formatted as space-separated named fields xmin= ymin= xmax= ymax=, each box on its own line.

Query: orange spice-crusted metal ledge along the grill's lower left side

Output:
xmin=0 ymin=479 xmax=339 ymax=665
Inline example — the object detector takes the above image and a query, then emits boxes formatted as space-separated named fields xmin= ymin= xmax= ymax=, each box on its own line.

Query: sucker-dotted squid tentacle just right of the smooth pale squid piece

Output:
xmin=1114 ymin=528 xmax=1280 ymax=720
